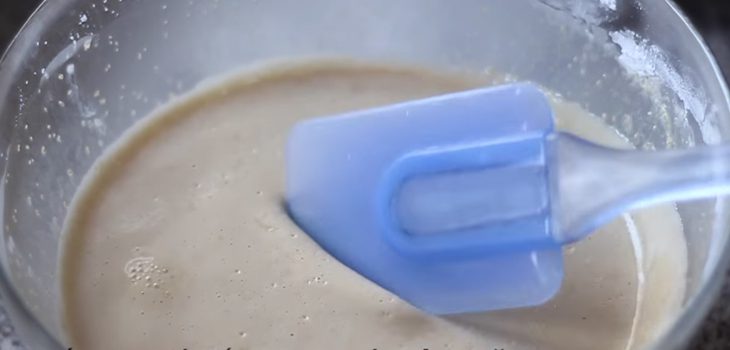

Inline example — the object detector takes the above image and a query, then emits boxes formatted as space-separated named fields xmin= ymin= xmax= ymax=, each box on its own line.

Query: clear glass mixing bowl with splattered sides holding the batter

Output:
xmin=0 ymin=0 xmax=730 ymax=349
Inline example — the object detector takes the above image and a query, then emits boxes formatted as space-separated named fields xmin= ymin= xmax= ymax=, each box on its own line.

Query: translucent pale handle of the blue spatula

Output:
xmin=548 ymin=133 xmax=730 ymax=243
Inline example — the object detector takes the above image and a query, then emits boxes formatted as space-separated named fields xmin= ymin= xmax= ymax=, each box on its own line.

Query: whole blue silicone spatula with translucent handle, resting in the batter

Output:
xmin=286 ymin=83 xmax=730 ymax=314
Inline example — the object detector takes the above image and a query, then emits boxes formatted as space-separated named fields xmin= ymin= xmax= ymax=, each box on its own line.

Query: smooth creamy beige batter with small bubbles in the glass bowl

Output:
xmin=61 ymin=61 xmax=686 ymax=350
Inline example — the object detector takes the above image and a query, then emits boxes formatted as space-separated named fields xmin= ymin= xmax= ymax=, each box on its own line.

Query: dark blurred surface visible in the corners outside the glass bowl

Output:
xmin=0 ymin=0 xmax=730 ymax=350
